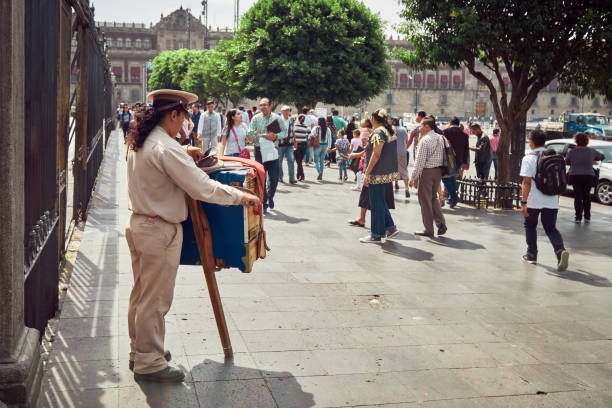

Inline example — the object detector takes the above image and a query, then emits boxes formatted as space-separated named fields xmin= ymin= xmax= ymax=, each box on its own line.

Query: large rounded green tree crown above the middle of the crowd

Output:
xmin=231 ymin=0 xmax=391 ymax=107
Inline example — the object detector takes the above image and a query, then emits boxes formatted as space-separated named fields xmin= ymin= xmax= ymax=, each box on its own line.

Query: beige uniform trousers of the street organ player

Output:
xmin=125 ymin=214 xmax=183 ymax=374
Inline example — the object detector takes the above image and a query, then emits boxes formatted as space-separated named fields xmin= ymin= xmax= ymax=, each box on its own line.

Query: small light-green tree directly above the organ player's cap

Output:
xmin=149 ymin=48 xmax=207 ymax=90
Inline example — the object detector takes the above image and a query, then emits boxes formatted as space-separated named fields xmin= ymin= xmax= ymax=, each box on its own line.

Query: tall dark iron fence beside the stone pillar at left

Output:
xmin=22 ymin=0 xmax=114 ymax=333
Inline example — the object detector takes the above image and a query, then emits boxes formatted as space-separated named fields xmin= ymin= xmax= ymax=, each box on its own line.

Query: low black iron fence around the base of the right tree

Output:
xmin=457 ymin=178 xmax=521 ymax=209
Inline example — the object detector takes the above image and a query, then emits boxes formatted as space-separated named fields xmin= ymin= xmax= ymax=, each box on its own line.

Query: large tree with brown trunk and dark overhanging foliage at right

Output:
xmin=396 ymin=0 xmax=612 ymax=184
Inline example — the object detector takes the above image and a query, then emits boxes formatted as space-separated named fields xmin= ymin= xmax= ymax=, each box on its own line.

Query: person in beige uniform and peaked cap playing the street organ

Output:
xmin=125 ymin=90 xmax=259 ymax=382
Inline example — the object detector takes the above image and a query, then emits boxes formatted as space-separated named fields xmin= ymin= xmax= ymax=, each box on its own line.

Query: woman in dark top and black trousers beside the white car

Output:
xmin=565 ymin=132 xmax=605 ymax=224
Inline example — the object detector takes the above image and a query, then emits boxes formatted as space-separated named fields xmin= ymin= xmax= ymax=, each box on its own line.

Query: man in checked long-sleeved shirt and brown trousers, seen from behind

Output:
xmin=409 ymin=116 xmax=447 ymax=238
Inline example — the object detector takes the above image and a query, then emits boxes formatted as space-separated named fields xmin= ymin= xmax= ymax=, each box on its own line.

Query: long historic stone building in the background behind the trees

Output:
xmin=97 ymin=7 xmax=612 ymax=119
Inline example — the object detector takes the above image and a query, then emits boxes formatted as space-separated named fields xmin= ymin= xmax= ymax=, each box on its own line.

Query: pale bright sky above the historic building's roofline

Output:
xmin=90 ymin=0 xmax=400 ymax=36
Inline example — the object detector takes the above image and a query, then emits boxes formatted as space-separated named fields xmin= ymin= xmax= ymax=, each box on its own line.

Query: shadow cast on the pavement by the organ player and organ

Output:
xmin=138 ymin=358 xmax=315 ymax=408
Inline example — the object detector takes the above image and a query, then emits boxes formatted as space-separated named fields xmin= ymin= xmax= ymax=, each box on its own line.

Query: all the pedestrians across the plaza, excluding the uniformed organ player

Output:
xmin=117 ymin=98 xmax=594 ymax=269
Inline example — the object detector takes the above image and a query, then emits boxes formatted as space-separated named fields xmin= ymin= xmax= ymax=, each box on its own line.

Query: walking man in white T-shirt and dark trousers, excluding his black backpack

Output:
xmin=520 ymin=130 xmax=569 ymax=271
